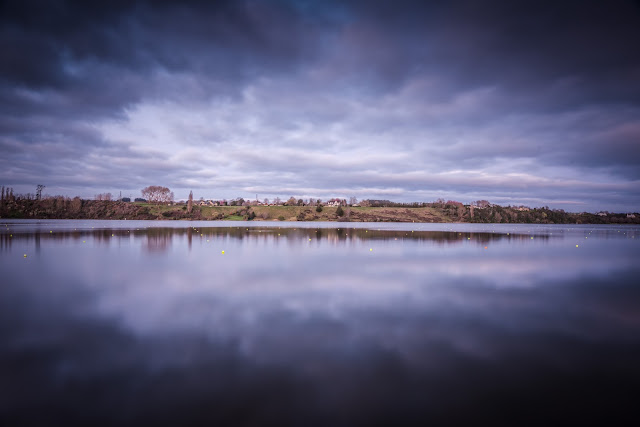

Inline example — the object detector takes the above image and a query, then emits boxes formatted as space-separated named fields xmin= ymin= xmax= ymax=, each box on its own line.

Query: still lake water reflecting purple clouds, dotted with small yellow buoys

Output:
xmin=0 ymin=220 xmax=640 ymax=426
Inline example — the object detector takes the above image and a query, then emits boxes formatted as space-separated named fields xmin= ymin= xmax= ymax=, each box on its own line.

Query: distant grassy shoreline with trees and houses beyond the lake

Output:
xmin=0 ymin=197 xmax=640 ymax=224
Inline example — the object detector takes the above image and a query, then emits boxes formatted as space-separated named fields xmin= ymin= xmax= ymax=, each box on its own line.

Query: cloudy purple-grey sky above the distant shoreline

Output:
xmin=0 ymin=0 xmax=640 ymax=212
